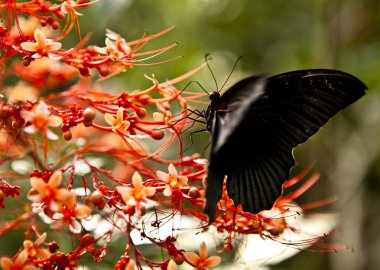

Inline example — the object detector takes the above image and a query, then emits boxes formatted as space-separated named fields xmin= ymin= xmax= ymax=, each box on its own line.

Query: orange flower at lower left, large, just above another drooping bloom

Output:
xmin=28 ymin=171 xmax=75 ymax=211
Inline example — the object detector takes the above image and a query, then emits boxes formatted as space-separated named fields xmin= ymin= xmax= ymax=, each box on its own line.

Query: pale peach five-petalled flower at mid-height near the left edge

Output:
xmin=21 ymin=102 xmax=62 ymax=140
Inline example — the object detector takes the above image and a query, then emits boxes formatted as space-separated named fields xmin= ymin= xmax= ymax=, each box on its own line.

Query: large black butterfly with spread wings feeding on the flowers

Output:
xmin=205 ymin=69 xmax=367 ymax=222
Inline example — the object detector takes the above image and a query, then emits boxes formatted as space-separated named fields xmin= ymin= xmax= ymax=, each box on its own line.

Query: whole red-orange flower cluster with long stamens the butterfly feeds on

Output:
xmin=0 ymin=0 xmax=343 ymax=270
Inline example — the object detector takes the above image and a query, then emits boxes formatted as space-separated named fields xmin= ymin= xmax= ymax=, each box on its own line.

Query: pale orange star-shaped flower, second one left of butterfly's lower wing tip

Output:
xmin=116 ymin=172 xmax=156 ymax=209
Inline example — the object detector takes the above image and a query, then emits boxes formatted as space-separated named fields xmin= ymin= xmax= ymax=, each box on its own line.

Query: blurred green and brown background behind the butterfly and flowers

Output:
xmin=80 ymin=0 xmax=380 ymax=270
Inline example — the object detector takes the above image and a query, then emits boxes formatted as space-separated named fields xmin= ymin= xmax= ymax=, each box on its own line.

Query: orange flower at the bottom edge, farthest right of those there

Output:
xmin=185 ymin=242 xmax=222 ymax=270
